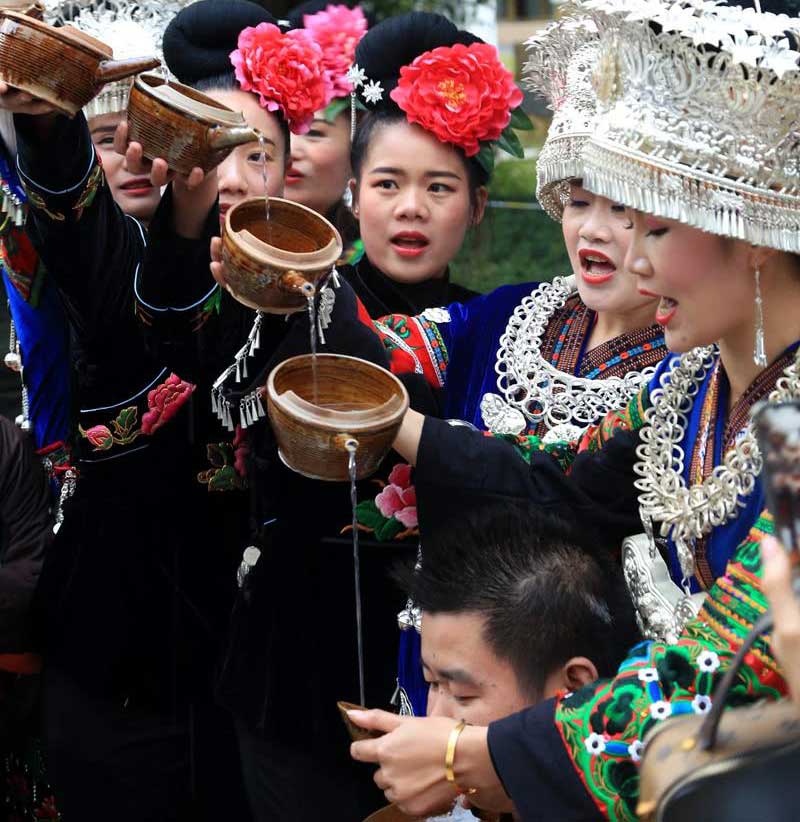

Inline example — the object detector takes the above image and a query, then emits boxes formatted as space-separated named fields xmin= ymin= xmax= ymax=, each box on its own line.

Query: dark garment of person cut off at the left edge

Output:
xmin=0 ymin=417 xmax=53 ymax=653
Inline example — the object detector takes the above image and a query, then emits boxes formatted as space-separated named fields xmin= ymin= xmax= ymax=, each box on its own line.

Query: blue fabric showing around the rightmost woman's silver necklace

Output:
xmin=650 ymin=352 xmax=797 ymax=592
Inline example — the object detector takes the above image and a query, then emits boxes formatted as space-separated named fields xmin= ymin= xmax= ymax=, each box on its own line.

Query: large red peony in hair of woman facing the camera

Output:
xmin=390 ymin=43 xmax=522 ymax=157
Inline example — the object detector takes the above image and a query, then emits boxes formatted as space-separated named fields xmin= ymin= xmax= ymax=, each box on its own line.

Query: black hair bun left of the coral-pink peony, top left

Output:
xmin=164 ymin=0 xmax=278 ymax=85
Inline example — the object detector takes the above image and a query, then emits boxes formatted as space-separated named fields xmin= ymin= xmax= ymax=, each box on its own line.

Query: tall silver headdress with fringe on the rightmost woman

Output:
xmin=581 ymin=0 xmax=800 ymax=252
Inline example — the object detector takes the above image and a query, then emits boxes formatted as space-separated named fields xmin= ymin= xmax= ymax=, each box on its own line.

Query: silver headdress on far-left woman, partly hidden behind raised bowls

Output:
xmin=45 ymin=0 xmax=192 ymax=118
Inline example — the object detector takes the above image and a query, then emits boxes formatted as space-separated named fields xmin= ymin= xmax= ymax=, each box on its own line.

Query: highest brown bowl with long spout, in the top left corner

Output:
xmin=0 ymin=10 xmax=160 ymax=117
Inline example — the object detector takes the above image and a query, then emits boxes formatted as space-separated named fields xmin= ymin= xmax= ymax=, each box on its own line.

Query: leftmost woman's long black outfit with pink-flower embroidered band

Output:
xmin=15 ymin=114 xmax=248 ymax=820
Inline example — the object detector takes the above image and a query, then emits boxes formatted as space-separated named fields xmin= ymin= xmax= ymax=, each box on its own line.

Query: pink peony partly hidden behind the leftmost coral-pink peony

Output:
xmin=303 ymin=6 xmax=368 ymax=97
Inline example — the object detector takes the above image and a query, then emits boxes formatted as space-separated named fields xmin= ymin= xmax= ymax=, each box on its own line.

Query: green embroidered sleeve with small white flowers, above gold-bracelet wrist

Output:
xmin=555 ymin=515 xmax=786 ymax=820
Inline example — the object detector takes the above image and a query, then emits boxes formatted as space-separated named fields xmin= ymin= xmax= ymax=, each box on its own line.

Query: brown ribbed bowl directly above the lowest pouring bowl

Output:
xmin=222 ymin=197 xmax=342 ymax=314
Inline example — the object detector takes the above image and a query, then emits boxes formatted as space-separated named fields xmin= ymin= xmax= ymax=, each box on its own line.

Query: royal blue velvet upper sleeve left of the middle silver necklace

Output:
xmin=437 ymin=283 xmax=538 ymax=430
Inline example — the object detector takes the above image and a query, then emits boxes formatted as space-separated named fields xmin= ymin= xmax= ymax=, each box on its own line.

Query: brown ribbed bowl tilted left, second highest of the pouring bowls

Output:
xmin=128 ymin=74 xmax=259 ymax=174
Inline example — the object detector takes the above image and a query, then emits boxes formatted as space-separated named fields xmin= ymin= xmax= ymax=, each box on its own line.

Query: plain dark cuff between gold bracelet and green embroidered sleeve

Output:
xmin=488 ymin=699 xmax=604 ymax=822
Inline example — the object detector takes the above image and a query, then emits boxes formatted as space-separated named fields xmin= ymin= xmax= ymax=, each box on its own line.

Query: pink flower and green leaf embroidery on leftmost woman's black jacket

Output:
xmin=78 ymin=374 xmax=195 ymax=451
